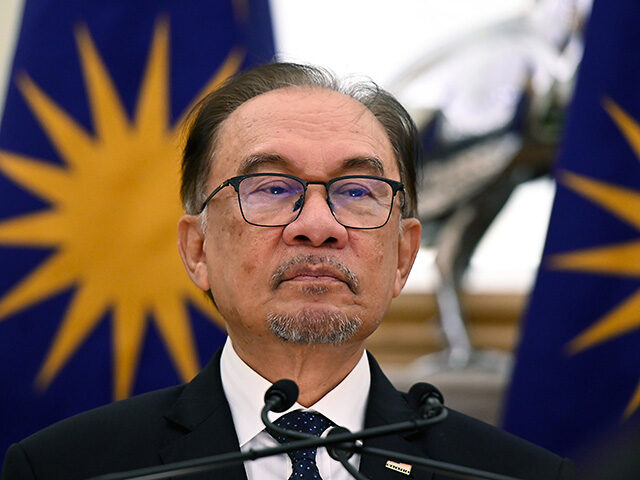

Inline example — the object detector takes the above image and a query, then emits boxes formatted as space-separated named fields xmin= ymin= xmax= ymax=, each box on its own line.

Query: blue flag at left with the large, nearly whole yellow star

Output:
xmin=0 ymin=0 xmax=274 ymax=461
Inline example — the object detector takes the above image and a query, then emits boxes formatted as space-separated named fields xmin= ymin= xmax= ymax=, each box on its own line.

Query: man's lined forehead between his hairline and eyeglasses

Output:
xmin=211 ymin=87 xmax=399 ymax=181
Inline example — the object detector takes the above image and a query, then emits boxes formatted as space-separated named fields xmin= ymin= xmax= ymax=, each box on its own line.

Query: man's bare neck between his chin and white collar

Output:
xmin=231 ymin=338 xmax=364 ymax=407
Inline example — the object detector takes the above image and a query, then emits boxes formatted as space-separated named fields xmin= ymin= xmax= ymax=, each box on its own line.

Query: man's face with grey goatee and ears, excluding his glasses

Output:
xmin=180 ymin=87 xmax=420 ymax=348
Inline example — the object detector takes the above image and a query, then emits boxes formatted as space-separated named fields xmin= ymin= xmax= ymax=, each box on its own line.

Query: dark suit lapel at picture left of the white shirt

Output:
xmin=160 ymin=351 xmax=247 ymax=480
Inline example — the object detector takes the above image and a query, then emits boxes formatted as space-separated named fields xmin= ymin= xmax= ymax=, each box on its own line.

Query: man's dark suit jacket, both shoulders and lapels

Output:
xmin=0 ymin=352 xmax=575 ymax=480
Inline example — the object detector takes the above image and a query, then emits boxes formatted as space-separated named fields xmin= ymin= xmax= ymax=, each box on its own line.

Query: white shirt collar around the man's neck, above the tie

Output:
xmin=220 ymin=338 xmax=371 ymax=447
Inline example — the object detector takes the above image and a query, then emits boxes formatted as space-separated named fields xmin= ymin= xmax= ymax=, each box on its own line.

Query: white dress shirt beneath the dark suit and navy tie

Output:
xmin=220 ymin=338 xmax=371 ymax=480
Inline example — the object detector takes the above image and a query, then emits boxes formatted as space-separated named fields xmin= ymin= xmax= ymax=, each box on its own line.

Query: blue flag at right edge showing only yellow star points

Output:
xmin=504 ymin=0 xmax=640 ymax=455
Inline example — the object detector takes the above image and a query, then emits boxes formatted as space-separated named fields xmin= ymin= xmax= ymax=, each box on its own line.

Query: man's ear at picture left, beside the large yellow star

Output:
xmin=178 ymin=215 xmax=210 ymax=291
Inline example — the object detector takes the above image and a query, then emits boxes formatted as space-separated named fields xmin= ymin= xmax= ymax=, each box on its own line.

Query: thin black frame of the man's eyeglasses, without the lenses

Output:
xmin=198 ymin=173 xmax=404 ymax=230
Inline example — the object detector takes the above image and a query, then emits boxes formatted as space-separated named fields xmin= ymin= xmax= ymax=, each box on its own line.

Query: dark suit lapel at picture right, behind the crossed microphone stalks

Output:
xmin=360 ymin=354 xmax=433 ymax=480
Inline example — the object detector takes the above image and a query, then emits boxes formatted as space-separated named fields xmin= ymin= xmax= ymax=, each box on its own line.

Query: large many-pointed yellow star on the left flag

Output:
xmin=0 ymin=20 xmax=244 ymax=399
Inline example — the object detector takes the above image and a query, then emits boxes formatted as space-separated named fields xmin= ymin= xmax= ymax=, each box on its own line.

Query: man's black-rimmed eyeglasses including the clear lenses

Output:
xmin=200 ymin=173 xmax=404 ymax=229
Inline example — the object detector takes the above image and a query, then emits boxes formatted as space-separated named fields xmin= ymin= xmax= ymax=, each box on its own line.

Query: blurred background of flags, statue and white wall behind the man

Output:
xmin=0 ymin=0 xmax=640 ymax=472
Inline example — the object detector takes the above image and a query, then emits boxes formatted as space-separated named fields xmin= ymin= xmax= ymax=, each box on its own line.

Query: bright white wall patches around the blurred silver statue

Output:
xmin=270 ymin=0 xmax=554 ymax=292
